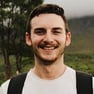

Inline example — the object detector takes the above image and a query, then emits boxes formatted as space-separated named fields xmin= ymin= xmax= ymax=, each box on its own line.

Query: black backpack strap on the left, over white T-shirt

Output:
xmin=7 ymin=73 xmax=27 ymax=94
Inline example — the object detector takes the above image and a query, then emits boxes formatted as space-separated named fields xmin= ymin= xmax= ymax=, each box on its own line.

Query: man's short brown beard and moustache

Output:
xmin=33 ymin=43 xmax=65 ymax=66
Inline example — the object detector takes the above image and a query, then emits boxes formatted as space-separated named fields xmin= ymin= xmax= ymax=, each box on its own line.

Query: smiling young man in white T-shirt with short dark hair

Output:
xmin=0 ymin=4 xmax=94 ymax=94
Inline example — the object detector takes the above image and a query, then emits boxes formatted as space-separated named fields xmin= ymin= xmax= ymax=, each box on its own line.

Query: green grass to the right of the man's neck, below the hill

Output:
xmin=65 ymin=53 xmax=94 ymax=75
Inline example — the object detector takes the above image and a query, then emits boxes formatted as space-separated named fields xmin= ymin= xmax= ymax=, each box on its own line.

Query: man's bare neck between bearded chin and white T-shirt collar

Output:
xmin=32 ymin=57 xmax=66 ymax=80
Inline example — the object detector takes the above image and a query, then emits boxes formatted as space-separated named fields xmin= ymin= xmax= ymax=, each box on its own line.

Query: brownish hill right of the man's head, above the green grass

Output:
xmin=67 ymin=16 xmax=94 ymax=53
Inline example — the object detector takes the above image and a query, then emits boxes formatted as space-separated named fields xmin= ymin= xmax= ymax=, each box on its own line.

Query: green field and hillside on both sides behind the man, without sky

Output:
xmin=0 ymin=17 xmax=94 ymax=84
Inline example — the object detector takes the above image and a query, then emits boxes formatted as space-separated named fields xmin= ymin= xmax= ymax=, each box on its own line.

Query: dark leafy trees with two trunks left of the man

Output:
xmin=0 ymin=0 xmax=43 ymax=79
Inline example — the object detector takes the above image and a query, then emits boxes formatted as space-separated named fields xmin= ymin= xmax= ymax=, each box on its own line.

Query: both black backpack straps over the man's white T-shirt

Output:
xmin=8 ymin=71 xmax=93 ymax=94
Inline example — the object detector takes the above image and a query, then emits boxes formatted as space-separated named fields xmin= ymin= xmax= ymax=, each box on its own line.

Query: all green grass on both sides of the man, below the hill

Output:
xmin=0 ymin=53 xmax=94 ymax=84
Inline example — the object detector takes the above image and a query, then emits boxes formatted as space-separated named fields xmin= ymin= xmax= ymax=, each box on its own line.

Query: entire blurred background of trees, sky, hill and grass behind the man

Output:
xmin=0 ymin=0 xmax=94 ymax=84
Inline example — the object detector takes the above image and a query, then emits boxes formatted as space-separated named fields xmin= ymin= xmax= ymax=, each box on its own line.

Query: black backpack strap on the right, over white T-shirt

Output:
xmin=76 ymin=71 xmax=93 ymax=94
